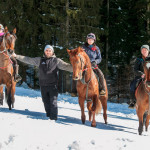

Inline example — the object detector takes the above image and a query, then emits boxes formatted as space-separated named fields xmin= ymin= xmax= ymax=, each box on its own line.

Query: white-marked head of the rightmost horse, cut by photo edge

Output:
xmin=143 ymin=57 xmax=150 ymax=87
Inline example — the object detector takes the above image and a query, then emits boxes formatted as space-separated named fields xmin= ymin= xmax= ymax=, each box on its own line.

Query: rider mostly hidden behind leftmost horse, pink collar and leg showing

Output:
xmin=0 ymin=24 xmax=22 ymax=82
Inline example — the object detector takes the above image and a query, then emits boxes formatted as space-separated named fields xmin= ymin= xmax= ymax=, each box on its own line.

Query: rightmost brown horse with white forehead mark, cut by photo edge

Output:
xmin=135 ymin=57 xmax=150 ymax=135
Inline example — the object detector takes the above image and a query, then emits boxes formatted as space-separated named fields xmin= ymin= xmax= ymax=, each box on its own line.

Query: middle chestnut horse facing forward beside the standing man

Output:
xmin=67 ymin=47 xmax=108 ymax=127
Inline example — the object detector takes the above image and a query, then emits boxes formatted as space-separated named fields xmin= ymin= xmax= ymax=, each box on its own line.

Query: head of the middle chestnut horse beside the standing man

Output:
xmin=67 ymin=47 xmax=86 ymax=80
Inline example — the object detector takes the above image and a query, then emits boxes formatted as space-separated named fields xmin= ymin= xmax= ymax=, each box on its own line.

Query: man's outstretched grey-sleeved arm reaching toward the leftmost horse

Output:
xmin=16 ymin=55 xmax=41 ymax=67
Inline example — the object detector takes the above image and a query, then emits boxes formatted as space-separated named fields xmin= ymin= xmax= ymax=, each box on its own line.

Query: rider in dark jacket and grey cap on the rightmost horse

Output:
xmin=129 ymin=45 xmax=149 ymax=108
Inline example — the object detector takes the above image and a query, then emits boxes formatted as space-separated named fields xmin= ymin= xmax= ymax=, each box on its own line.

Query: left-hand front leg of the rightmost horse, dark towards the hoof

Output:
xmin=136 ymin=106 xmax=144 ymax=135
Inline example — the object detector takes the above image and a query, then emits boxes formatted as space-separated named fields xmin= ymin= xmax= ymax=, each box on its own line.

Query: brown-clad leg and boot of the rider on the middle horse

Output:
xmin=97 ymin=68 xmax=106 ymax=95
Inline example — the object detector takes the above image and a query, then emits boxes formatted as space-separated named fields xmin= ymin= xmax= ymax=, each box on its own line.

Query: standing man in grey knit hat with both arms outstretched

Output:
xmin=13 ymin=45 xmax=73 ymax=120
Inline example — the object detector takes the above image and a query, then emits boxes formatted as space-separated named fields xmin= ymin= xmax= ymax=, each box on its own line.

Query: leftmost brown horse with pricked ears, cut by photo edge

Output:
xmin=0 ymin=27 xmax=16 ymax=110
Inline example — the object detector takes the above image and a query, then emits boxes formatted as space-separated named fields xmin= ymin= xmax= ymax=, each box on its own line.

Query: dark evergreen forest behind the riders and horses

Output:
xmin=0 ymin=0 xmax=150 ymax=102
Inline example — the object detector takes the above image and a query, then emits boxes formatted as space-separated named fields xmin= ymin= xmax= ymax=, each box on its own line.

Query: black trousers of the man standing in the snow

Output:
xmin=41 ymin=85 xmax=58 ymax=120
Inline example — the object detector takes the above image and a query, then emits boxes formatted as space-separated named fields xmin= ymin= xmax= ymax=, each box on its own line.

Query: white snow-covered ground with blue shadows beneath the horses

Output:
xmin=0 ymin=85 xmax=150 ymax=150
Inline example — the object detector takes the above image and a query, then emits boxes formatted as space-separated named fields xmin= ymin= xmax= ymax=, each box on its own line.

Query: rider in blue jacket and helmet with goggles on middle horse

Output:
xmin=83 ymin=33 xmax=105 ymax=95
